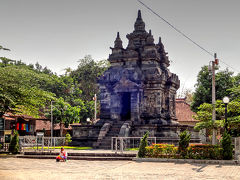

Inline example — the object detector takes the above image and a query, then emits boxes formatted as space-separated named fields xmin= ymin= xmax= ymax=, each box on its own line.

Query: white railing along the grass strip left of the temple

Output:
xmin=19 ymin=136 xmax=65 ymax=152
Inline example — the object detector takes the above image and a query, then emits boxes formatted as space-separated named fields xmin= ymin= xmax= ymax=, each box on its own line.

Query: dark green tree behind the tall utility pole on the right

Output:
xmin=191 ymin=66 xmax=236 ymax=112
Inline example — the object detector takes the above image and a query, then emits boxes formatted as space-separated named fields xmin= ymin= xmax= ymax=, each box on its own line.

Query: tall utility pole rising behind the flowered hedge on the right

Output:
xmin=212 ymin=53 xmax=218 ymax=145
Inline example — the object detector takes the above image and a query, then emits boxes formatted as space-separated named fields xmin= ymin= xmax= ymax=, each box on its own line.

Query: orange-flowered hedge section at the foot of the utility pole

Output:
xmin=187 ymin=144 xmax=222 ymax=159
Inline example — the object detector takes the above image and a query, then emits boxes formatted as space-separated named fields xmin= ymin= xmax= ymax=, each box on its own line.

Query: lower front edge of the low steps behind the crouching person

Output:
xmin=15 ymin=155 xmax=132 ymax=161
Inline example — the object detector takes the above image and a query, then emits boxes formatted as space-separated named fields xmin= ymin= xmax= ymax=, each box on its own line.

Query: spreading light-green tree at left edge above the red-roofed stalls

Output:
xmin=0 ymin=66 xmax=54 ymax=117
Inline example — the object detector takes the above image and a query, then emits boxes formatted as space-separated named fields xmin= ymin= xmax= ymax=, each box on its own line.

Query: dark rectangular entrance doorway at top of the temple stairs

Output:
xmin=120 ymin=92 xmax=131 ymax=121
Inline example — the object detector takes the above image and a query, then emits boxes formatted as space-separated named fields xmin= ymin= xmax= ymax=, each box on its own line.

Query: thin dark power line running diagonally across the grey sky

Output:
xmin=137 ymin=0 xmax=240 ymax=73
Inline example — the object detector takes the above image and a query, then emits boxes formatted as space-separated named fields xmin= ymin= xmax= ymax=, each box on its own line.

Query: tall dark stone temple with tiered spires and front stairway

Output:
xmin=73 ymin=10 xmax=201 ymax=148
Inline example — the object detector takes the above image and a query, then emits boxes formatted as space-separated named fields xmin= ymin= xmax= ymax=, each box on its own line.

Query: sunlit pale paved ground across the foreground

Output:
xmin=0 ymin=158 xmax=240 ymax=180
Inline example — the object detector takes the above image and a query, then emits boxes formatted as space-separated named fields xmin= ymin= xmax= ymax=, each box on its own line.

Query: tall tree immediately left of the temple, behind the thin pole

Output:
xmin=64 ymin=55 xmax=109 ymax=122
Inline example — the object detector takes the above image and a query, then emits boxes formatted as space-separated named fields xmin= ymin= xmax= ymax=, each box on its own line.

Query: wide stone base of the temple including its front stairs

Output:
xmin=72 ymin=121 xmax=201 ymax=149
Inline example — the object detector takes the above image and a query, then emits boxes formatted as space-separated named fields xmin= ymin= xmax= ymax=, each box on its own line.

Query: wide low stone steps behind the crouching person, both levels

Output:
xmin=16 ymin=152 xmax=136 ymax=161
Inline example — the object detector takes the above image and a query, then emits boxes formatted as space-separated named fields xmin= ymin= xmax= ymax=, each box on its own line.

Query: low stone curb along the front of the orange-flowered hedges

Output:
xmin=132 ymin=157 xmax=240 ymax=165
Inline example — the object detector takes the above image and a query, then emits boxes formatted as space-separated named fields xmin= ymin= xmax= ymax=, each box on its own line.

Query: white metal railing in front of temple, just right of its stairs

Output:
xmin=111 ymin=137 xmax=156 ymax=152
